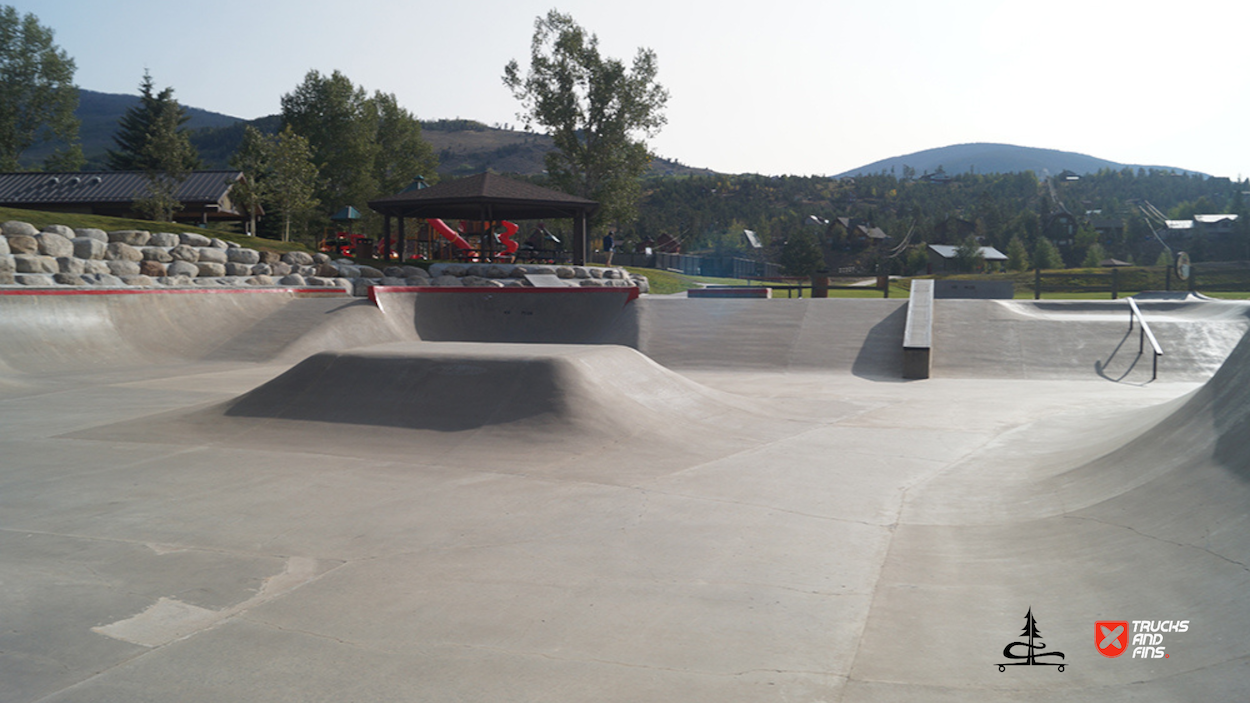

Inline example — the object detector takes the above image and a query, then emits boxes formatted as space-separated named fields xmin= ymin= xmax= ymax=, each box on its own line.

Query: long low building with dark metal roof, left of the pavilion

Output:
xmin=0 ymin=170 xmax=246 ymax=223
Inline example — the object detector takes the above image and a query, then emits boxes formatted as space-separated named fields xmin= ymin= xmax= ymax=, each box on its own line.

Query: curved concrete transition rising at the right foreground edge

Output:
xmin=848 ymin=322 xmax=1250 ymax=700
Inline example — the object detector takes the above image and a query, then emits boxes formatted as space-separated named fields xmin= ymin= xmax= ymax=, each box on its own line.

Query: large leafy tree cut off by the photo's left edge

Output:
xmin=0 ymin=5 xmax=84 ymax=171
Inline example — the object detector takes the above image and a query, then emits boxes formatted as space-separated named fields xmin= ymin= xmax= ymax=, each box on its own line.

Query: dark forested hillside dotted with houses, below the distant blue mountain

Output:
xmin=625 ymin=169 xmax=1250 ymax=273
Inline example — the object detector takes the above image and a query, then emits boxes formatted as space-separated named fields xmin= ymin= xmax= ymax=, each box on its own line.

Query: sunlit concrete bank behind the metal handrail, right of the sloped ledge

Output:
xmin=933 ymin=300 xmax=1250 ymax=383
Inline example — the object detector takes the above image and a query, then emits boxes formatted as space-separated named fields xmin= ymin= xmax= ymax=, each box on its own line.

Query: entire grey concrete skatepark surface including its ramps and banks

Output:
xmin=0 ymin=287 xmax=1250 ymax=703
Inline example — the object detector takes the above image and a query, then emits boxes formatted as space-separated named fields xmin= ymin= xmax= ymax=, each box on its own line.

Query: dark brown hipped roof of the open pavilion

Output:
xmin=369 ymin=173 xmax=599 ymax=220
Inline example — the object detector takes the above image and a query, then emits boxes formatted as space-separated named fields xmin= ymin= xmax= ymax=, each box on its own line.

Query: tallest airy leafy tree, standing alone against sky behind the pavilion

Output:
xmin=504 ymin=10 xmax=669 ymax=223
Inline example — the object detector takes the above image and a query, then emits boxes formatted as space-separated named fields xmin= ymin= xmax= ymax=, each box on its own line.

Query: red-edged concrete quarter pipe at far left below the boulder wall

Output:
xmin=0 ymin=289 xmax=410 ymax=383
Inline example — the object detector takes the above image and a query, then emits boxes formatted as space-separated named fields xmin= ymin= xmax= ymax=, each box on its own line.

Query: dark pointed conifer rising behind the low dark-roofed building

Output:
xmin=106 ymin=71 xmax=200 ymax=171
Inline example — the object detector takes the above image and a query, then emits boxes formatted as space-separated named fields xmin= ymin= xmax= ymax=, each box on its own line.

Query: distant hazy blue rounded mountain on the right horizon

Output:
xmin=835 ymin=144 xmax=1196 ymax=178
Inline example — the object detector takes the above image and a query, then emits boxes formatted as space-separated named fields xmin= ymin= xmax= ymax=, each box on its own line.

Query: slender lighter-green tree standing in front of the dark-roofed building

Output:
xmin=135 ymin=101 xmax=199 ymax=221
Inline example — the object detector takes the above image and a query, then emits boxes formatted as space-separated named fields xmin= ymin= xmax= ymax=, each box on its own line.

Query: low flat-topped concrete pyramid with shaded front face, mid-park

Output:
xmin=85 ymin=341 xmax=830 ymax=480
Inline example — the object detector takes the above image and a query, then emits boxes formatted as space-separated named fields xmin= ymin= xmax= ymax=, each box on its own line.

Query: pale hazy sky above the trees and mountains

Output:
xmin=11 ymin=0 xmax=1250 ymax=178
